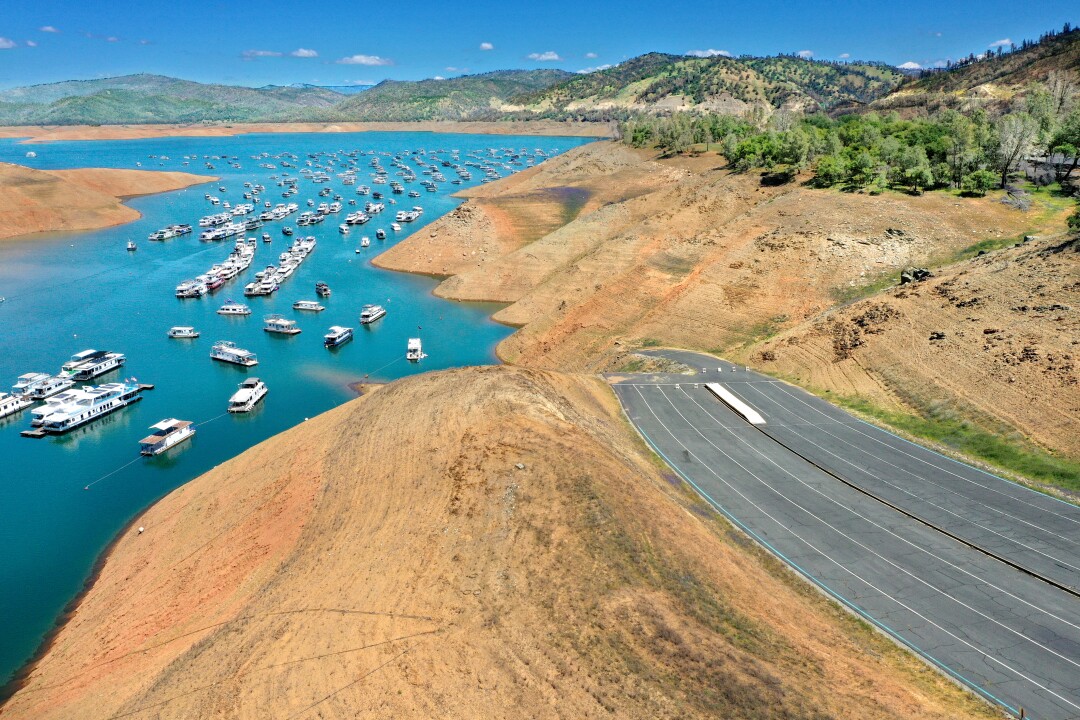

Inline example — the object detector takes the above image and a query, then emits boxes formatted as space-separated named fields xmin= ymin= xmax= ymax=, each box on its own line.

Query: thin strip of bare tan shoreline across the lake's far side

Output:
xmin=0 ymin=120 xmax=612 ymax=142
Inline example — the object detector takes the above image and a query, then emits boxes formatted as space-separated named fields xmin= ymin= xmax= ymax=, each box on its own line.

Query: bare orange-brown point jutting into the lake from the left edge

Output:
xmin=0 ymin=163 xmax=217 ymax=241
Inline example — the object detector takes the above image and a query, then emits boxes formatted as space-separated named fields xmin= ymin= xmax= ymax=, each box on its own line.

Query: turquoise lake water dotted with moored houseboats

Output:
xmin=0 ymin=133 xmax=589 ymax=680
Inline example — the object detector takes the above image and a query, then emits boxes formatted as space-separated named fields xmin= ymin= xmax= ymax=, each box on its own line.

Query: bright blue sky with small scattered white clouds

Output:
xmin=0 ymin=0 xmax=1080 ymax=87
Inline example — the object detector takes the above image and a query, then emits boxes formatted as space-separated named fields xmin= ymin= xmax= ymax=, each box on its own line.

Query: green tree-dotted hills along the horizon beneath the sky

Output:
xmin=0 ymin=28 xmax=1080 ymax=125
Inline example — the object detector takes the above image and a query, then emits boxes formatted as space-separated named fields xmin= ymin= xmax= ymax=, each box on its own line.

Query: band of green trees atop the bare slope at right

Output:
xmin=621 ymin=72 xmax=1080 ymax=194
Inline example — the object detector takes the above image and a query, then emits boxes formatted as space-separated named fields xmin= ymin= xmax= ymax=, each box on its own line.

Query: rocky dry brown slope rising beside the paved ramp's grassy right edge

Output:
xmin=740 ymin=236 xmax=1080 ymax=457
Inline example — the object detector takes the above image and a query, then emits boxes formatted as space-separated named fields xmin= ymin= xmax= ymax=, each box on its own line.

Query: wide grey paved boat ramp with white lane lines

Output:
xmin=615 ymin=351 xmax=1080 ymax=720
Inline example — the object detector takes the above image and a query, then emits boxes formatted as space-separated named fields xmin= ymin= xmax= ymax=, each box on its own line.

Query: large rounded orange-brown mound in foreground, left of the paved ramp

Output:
xmin=0 ymin=367 xmax=996 ymax=720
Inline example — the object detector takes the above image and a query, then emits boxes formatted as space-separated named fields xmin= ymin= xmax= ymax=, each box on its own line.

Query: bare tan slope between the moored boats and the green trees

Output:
xmin=376 ymin=142 xmax=1045 ymax=369
